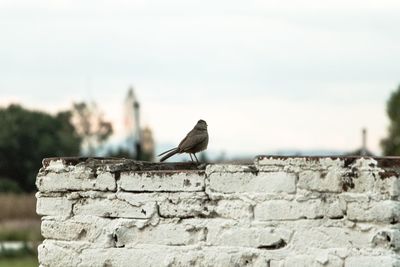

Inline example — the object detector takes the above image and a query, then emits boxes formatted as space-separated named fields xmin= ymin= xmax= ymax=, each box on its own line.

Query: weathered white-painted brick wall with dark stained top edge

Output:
xmin=37 ymin=157 xmax=400 ymax=267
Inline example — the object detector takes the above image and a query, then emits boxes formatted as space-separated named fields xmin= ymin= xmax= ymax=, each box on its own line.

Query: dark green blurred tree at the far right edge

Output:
xmin=381 ymin=86 xmax=400 ymax=156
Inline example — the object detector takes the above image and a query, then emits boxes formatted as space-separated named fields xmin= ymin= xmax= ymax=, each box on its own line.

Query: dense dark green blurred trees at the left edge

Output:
xmin=0 ymin=105 xmax=81 ymax=191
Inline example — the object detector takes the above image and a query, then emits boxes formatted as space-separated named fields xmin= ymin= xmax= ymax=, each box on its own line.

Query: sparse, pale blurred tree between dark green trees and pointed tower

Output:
xmin=71 ymin=102 xmax=113 ymax=156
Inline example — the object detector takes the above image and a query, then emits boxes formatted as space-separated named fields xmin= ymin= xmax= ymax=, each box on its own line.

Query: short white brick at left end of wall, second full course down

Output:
xmin=36 ymin=196 xmax=73 ymax=217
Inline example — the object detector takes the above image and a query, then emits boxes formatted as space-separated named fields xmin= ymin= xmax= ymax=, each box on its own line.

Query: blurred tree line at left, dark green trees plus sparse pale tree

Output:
xmin=0 ymin=103 xmax=112 ymax=192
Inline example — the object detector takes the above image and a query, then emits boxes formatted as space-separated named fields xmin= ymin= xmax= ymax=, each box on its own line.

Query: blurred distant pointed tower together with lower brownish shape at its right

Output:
xmin=123 ymin=87 xmax=154 ymax=160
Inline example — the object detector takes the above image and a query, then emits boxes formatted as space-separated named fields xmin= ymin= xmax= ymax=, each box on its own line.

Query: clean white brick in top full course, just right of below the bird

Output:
xmin=209 ymin=172 xmax=296 ymax=193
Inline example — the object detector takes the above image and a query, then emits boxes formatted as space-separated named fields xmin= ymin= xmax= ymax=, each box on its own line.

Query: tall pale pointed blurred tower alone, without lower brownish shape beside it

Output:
xmin=124 ymin=87 xmax=142 ymax=159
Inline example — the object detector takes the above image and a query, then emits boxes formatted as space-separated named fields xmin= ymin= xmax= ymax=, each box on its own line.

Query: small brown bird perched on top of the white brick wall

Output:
xmin=158 ymin=120 xmax=208 ymax=163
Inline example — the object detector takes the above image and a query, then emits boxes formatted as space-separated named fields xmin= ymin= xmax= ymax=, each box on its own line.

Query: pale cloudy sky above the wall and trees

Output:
xmin=0 ymin=0 xmax=400 ymax=155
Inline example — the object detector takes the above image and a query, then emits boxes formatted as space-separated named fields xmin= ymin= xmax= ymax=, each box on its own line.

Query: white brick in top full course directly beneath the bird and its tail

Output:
xmin=118 ymin=171 xmax=204 ymax=192
